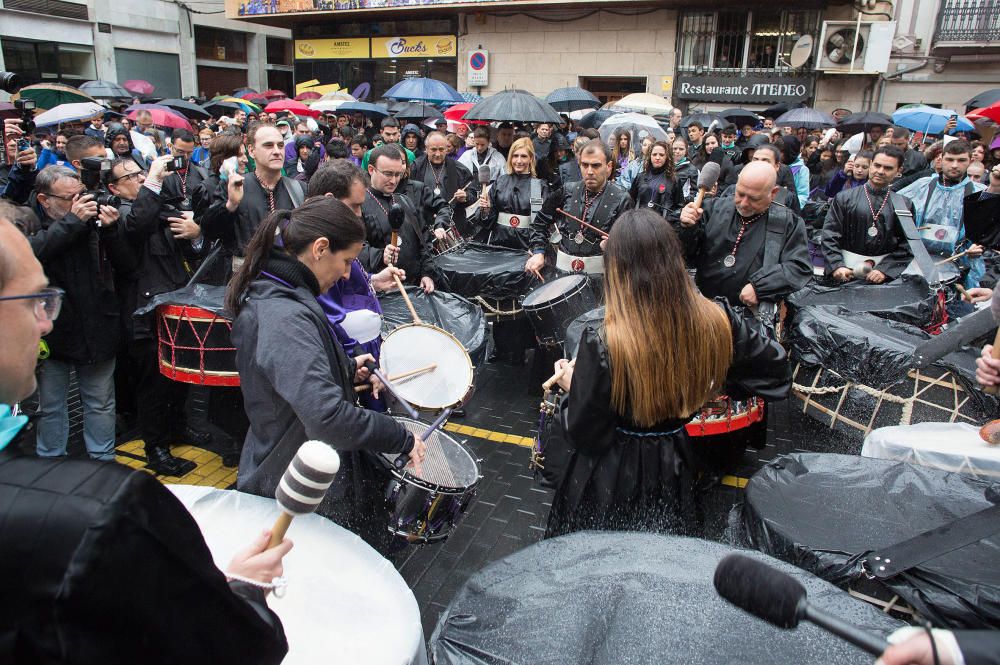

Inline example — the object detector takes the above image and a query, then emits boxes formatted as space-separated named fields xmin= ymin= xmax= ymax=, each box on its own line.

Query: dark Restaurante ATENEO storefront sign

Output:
xmin=674 ymin=75 xmax=813 ymax=104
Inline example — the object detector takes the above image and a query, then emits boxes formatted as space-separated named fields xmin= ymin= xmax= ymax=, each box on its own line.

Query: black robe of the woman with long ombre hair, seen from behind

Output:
xmin=545 ymin=301 xmax=792 ymax=537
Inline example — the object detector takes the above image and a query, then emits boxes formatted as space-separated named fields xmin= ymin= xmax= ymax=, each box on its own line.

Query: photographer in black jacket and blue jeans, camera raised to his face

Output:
xmin=28 ymin=163 xmax=136 ymax=460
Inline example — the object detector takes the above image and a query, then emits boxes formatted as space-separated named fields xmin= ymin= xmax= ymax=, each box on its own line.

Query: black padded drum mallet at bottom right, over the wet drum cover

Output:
xmin=713 ymin=554 xmax=889 ymax=656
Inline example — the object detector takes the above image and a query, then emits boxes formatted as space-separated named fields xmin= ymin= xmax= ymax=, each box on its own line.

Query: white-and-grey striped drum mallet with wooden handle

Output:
xmin=267 ymin=441 xmax=340 ymax=549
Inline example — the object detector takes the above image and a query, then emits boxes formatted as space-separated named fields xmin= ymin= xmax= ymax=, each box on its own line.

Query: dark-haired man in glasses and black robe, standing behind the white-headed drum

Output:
xmin=359 ymin=145 xmax=434 ymax=293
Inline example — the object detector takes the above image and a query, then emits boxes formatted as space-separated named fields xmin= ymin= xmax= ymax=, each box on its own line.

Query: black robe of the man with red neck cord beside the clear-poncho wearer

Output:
xmin=822 ymin=185 xmax=913 ymax=280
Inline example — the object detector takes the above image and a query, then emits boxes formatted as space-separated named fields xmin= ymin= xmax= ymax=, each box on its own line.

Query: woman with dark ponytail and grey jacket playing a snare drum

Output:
xmin=226 ymin=197 xmax=425 ymax=553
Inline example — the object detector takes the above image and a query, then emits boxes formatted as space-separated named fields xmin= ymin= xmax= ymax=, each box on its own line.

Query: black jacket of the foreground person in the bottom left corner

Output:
xmin=0 ymin=448 xmax=288 ymax=665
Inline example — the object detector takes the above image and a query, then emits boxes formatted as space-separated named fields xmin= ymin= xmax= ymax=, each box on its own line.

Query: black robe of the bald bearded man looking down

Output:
xmin=679 ymin=198 xmax=813 ymax=306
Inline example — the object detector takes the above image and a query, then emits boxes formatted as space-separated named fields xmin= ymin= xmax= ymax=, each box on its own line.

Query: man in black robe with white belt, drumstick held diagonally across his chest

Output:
xmin=524 ymin=139 xmax=632 ymax=279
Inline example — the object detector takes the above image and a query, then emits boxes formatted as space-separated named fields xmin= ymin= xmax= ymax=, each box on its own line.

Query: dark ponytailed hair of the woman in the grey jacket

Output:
xmin=226 ymin=196 xmax=365 ymax=316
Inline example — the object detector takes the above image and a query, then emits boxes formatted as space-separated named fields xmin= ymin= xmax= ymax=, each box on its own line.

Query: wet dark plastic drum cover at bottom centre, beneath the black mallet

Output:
xmin=431 ymin=531 xmax=903 ymax=665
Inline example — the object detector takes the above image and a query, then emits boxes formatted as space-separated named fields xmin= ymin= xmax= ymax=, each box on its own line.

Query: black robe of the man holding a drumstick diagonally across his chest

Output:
xmin=529 ymin=180 xmax=632 ymax=256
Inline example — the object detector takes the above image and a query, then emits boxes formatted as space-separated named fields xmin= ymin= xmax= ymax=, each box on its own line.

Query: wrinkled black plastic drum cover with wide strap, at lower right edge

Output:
xmin=730 ymin=453 xmax=1000 ymax=628
